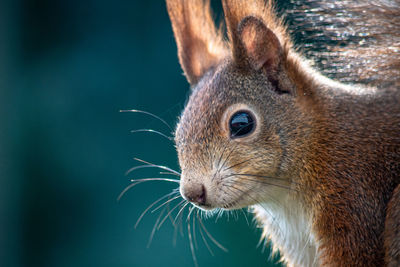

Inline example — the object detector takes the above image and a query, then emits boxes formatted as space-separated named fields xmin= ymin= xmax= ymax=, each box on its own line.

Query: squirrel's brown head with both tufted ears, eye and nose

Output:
xmin=167 ymin=0 xmax=318 ymax=209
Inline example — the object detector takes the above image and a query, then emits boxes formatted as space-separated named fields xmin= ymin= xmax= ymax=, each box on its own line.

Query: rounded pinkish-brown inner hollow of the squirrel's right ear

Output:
xmin=238 ymin=16 xmax=283 ymax=73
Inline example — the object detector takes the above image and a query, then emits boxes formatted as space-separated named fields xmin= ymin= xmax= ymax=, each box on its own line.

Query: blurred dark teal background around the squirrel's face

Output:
xmin=0 ymin=0 xmax=296 ymax=267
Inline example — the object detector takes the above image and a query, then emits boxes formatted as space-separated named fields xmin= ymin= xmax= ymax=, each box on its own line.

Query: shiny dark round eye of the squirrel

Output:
xmin=229 ymin=110 xmax=255 ymax=138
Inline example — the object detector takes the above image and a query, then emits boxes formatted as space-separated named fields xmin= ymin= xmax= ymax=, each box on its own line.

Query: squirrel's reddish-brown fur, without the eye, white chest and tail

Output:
xmin=167 ymin=0 xmax=400 ymax=266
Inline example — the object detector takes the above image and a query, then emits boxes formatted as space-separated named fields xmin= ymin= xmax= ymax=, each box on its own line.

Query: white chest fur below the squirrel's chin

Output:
xmin=252 ymin=199 xmax=318 ymax=267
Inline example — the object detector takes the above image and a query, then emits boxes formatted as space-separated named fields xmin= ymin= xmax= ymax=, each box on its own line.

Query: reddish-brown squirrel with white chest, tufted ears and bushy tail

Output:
xmin=167 ymin=0 xmax=400 ymax=266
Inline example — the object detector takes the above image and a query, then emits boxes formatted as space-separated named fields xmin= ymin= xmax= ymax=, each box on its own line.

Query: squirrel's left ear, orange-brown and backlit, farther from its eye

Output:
xmin=167 ymin=0 xmax=228 ymax=85
